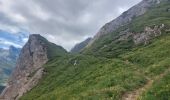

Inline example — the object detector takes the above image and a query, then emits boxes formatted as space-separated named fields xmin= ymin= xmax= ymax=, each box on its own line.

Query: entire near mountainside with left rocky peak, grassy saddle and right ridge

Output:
xmin=0 ymin=0 xmax=170 ymax=100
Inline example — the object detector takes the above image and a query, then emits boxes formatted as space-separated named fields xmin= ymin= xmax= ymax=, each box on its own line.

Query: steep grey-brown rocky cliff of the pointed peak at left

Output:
xmin=2 ymin=34 xmax=66 ymax=100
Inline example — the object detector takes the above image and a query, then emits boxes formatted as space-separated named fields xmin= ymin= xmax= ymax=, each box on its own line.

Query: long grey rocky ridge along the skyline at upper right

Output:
xmin=88 ymin=0 xmax=169 ymax=46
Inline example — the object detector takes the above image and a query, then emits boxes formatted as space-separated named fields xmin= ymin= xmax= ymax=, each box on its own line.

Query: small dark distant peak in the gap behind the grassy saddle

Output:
xmin=70 ymin=38 xmax=92 ymax=53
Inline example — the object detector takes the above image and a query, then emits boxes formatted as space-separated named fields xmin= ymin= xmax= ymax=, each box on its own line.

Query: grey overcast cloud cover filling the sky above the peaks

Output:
xmin=0 ymin=0 xmax=141 ymax=50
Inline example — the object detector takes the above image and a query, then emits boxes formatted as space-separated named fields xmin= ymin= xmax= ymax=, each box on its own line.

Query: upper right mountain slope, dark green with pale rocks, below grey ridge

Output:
xmin=84 ymin=0 xmax=169 ymax=58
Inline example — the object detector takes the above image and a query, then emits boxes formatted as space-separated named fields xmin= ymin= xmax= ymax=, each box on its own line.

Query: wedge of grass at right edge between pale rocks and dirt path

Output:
xmin=119 ymin=34 xmax=170 ymax=76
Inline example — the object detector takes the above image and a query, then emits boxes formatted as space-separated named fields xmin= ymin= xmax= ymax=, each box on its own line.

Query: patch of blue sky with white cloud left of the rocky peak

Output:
xmin=0 ymin=30 xmax=29 ymax=49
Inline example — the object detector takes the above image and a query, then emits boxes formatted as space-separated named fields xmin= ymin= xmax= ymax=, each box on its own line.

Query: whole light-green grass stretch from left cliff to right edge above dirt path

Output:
xmin=21 ymin=32 xmax=170 ymax=100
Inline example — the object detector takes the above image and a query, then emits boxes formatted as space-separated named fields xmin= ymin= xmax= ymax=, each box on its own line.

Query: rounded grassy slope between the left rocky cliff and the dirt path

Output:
xmin=21 ymin=55 xmax=146 ymax=100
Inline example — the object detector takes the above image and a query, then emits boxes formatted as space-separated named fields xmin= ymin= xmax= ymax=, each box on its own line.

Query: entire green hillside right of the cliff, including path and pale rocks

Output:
xmin=20 ymin=0 xmax=170 ymax=100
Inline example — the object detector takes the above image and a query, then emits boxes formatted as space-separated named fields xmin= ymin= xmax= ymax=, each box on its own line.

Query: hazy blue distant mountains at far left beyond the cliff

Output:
xmin=0 ymin=46 xmax=21 ymax=85
